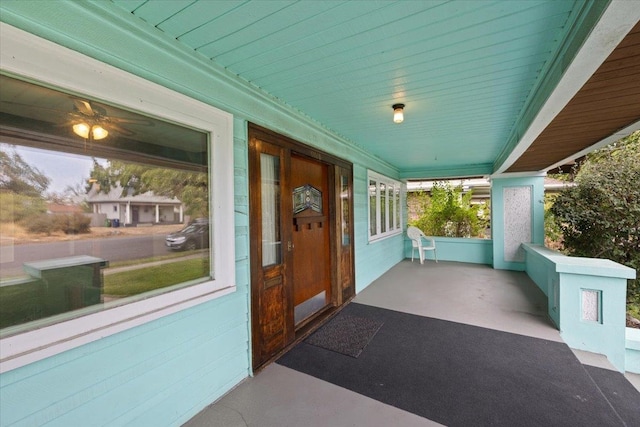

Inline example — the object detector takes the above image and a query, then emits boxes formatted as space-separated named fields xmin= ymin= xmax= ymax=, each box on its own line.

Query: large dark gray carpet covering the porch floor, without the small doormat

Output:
xmin=277 ymin=303 xmax=640 ymax=427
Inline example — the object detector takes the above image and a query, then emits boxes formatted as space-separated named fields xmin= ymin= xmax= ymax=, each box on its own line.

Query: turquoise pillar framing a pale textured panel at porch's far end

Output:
xmin=491 ymin=176 xmax=544 ymax=271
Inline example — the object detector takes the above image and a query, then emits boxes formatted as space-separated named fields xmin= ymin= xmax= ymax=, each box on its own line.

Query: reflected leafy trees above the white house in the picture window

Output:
xmin=88 ymin=159 xmax=209 ymax=217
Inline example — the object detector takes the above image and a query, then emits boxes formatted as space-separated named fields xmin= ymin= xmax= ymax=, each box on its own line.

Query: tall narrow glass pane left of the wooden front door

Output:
xmin=260 ymin=153 xmax=282 ymax=266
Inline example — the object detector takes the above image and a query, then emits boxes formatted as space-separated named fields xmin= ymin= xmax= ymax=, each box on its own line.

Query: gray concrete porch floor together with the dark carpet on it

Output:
xmin=185 ymin=259 xmax=640 ymax=427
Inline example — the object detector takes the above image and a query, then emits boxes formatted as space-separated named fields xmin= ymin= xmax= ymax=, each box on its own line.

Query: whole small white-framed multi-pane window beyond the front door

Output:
xmin=368 ymin=171 xmax=402 ymax=241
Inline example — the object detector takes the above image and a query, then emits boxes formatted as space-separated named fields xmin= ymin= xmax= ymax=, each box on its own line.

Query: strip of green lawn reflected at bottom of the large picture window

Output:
xmin=104 ymin=258 xmax=209 ymax=297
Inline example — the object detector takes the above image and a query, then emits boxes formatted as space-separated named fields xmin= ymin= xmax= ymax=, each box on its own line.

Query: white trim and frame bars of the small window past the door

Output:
xmin=367 ymin=170 xmax=402 ymax=243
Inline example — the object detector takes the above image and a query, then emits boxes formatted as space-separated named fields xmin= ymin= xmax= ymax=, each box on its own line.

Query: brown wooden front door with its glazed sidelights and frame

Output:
xmin=249 ymin=125 xmax=355 ymax=369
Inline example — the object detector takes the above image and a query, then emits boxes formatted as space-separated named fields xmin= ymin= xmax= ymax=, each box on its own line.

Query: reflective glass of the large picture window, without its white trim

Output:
xmin=0 ymin=76 xmax=213 ymax=336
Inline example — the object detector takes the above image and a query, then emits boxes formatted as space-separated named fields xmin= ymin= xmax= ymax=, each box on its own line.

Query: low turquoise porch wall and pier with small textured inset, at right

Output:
xmin=523 ymin=244 xmax=636 ymax=372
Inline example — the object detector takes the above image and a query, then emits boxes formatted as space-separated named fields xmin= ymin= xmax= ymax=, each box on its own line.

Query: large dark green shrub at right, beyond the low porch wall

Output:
xmin=551 ymin=131 xmax=640 ymax=304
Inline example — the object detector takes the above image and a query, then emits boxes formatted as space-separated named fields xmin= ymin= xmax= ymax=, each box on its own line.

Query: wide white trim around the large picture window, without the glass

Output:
xmin=0 ymin=22 xmax=236 ymax=373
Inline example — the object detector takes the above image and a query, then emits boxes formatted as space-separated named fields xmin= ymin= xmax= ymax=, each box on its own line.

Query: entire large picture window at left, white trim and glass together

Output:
xmin=0 ymin=24 xmax=235 ymax=372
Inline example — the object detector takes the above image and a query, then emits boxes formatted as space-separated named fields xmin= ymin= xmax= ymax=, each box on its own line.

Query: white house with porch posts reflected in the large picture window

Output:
xmin=87 ymin=187 xmax=184 ymax=225
